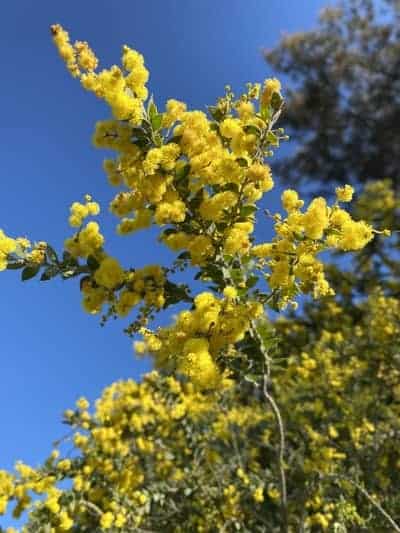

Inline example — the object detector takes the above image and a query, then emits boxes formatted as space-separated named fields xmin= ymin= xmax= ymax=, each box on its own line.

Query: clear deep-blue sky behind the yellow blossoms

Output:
xmin=0 ymin=0 xmax=326 ymax=524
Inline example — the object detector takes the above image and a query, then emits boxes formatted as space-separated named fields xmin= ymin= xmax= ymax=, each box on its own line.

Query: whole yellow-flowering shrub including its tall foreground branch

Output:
xmin=0 ymin=25 xmax=400 ymax=533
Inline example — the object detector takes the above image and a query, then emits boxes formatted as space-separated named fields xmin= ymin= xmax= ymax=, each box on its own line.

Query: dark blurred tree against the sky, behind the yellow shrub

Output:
xmin=265 ymin=0 xmax=400 ymax=192
